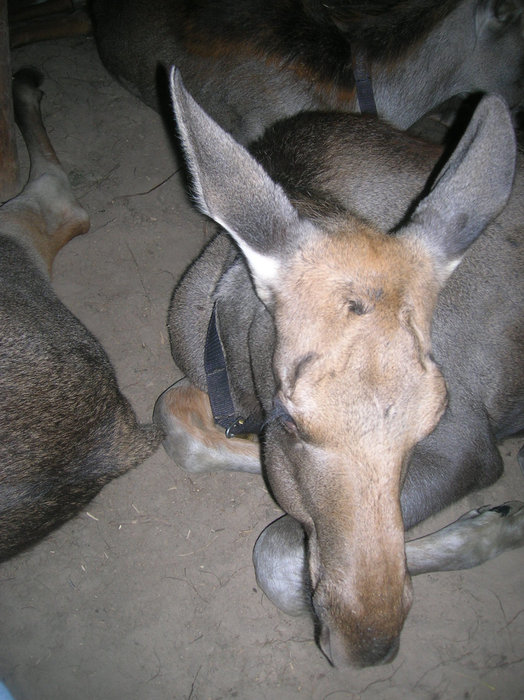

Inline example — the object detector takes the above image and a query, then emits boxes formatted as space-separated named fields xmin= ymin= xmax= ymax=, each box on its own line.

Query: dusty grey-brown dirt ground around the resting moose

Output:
xmin=0 ymin=39 xmax=524 ymax=700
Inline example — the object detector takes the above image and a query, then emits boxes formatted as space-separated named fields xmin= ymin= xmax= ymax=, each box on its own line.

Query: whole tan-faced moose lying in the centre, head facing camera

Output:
xmin=155 ymin=75 xmax=524 ymax=666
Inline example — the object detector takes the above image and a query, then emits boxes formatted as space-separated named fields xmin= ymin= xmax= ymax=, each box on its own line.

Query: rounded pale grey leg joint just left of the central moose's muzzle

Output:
xmin=253 ymin=515 xmax=312 ymax=615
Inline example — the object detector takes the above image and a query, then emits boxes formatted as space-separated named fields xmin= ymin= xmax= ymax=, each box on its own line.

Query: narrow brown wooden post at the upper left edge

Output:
xmin=0 ymin=0 xmax=19 ymax=203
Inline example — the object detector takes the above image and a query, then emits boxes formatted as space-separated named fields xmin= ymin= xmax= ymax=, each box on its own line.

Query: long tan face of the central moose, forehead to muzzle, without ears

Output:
xmin=268 ymin=222 xmax=446 ymax=665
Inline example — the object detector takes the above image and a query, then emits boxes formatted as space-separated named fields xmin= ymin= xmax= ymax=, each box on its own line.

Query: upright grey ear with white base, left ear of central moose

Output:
xmin=171 ymin=68 xmax=314 ymax=303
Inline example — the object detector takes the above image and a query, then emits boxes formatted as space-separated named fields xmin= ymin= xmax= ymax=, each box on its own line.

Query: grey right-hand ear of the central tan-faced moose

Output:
xmin=402 ymin=96 xmax=516 ymax=282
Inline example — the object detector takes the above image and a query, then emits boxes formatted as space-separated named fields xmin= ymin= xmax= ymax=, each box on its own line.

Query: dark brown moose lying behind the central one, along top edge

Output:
xmin=93 ymin=0 xmax=524 ymax=144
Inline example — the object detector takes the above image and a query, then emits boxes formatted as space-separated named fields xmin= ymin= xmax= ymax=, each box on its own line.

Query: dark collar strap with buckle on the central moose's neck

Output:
xmin=204 ymin=302 xmax=261 ymax=438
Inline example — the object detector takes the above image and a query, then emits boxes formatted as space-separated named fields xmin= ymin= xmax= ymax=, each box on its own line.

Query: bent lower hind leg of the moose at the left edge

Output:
xmin=0 ymin=68 xmax=89 ymax=272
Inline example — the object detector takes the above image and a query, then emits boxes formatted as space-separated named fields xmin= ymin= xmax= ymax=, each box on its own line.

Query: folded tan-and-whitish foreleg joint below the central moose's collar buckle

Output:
xmin=153 ymin=378 xmax=260 ymax=473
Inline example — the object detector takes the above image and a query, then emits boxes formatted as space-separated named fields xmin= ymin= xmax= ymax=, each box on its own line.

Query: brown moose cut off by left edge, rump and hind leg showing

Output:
xmin=0 ymin=68 xmax=160 ymax=560
